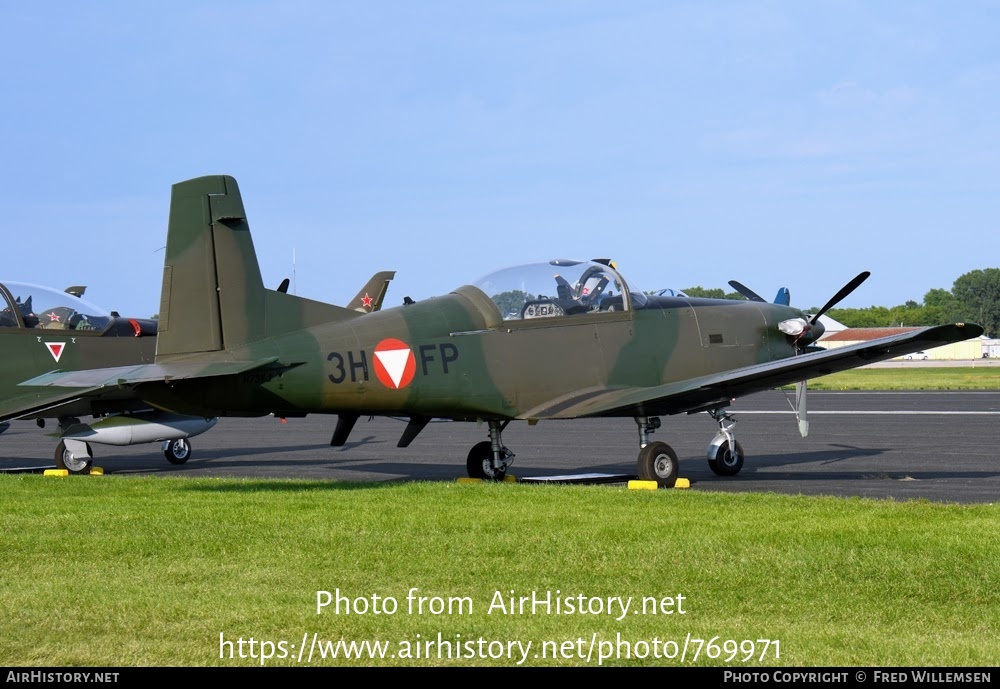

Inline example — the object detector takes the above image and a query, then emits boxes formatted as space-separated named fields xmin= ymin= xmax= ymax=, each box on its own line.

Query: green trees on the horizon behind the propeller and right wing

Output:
xmin=684 ymin=268 xmax=1000 ymax=337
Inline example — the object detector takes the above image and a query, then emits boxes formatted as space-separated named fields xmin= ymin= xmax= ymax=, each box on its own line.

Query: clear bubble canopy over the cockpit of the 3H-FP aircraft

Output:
xmin=473 ymin=259 xmax=646 ymax=320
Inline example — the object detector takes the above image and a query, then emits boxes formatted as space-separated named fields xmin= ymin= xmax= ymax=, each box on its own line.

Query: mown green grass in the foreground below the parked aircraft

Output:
xmin=0 ymin=475 xmax=1000 ymax=667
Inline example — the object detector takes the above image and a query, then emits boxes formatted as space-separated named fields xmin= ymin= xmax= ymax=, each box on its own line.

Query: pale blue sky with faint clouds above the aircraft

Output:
xmin=0 ymin=0 xmax=1000 ymax=316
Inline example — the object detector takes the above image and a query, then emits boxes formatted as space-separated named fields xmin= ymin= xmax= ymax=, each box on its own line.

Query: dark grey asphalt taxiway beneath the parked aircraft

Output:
xmin=0 ymin=391 xmax=1000 ymax=503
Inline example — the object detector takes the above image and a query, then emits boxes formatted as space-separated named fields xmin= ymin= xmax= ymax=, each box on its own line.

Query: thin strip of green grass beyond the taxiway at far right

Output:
xmin=809 ymin=366 xmax=1000 ymax=390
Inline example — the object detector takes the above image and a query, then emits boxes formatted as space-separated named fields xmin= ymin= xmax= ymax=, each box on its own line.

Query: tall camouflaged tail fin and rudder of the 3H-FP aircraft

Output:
xmin=156 ymin=175 xmax=265 ymax=357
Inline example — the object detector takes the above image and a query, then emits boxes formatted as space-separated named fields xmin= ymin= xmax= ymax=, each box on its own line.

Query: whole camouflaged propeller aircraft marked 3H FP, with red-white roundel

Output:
xmin=0 ymin=176 xmax=982 ymax=486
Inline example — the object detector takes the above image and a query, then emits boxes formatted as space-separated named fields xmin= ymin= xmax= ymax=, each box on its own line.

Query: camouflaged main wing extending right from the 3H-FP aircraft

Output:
xmin=519 ymin=324 xmax=983 ymax=419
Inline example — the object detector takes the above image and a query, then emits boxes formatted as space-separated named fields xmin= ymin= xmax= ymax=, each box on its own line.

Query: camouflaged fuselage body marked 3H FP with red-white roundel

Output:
xmin=139 ymin=287 xmax=804 ymax=419
